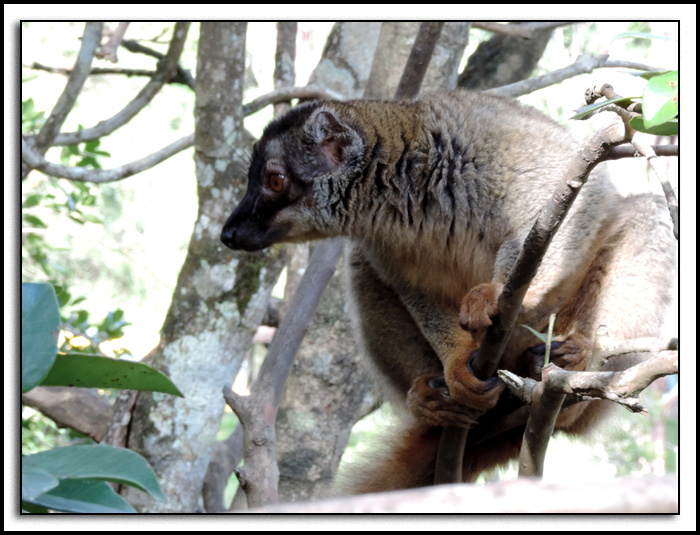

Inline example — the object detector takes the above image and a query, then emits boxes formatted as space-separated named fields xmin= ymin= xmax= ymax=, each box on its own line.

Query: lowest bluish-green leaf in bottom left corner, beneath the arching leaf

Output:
xmin=25 ymin=479 xmax=136 ymax=513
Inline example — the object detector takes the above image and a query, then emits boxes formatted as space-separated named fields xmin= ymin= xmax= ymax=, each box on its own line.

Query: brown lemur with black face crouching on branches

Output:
xmin=221 ymin=91 xmax=676 ymax=492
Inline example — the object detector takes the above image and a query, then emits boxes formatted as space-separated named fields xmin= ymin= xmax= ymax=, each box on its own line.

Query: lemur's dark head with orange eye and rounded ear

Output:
xmin=221 ymin=103 xmax=361 ymax=251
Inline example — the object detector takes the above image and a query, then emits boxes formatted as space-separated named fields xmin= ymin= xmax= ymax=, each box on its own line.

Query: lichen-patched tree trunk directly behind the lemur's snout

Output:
xmin=125 ymin=22 xmax=283 ymax=513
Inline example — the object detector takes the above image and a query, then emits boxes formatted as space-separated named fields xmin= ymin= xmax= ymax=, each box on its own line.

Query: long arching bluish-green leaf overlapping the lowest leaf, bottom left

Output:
xmin=22 ymin=445 xmax=165 ymax=507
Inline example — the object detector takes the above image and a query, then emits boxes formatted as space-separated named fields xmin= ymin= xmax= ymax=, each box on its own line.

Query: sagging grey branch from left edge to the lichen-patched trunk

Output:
xmin=22 ymin=134 xmax=194 ymax=184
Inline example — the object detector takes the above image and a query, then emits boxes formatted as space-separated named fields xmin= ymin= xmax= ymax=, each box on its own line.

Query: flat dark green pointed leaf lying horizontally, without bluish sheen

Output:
xmin=41 ymin=354 xmax=183 ymax=397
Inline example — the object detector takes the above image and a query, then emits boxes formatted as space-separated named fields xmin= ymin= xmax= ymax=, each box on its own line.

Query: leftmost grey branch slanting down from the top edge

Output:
xmin=22 ymin=22 xmax=102 ymax=180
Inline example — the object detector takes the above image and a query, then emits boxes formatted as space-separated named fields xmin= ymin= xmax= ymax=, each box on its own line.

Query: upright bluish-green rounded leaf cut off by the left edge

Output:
xmin=22 ymin=282 xmax=59 ymax=392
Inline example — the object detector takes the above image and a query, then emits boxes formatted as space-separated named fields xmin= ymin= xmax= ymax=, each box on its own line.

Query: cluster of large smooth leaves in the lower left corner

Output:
xmin=22 ymin=283 xmax=182 ymax=513
